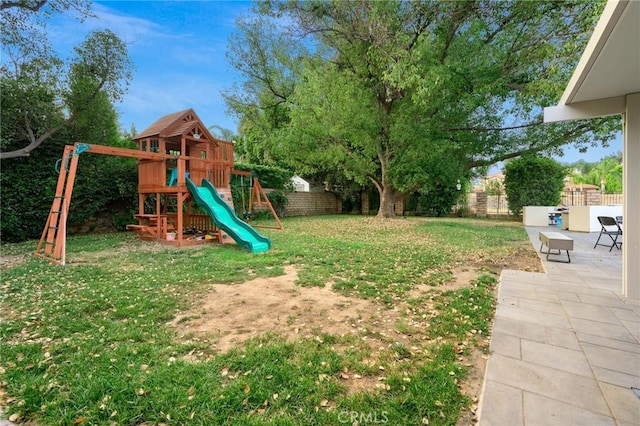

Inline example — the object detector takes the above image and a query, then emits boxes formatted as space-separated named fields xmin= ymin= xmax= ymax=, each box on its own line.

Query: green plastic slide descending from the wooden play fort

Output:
xmin=186 ymin=178 xmax=271 ymax=253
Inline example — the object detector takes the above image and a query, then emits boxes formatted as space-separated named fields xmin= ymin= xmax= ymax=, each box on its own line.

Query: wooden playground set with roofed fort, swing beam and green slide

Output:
xmin=35 ymin=109 xmax=282 ymax=265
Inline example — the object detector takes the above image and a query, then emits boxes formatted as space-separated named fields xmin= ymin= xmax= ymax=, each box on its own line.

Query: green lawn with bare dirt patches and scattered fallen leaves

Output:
xmin=0 ymin=216 xmax=539 ymax=425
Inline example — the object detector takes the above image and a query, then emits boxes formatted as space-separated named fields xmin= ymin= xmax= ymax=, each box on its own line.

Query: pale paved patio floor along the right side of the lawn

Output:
xmin=479 ymin=227 xmax=640 ymax=426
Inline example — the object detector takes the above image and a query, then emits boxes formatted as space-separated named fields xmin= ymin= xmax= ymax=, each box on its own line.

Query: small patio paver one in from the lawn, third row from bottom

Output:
xmin=522 ymin=340 xmax=593 ymax=377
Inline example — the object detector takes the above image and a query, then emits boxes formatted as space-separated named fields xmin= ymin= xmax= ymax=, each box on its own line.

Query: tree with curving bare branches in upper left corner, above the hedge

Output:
xmin=0 ymin=0 xmax=133 ymax=159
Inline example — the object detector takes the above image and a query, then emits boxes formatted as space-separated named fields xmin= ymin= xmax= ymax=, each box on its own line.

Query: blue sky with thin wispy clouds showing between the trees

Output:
xmin=48 ymin=0 xmax=622 ymax=163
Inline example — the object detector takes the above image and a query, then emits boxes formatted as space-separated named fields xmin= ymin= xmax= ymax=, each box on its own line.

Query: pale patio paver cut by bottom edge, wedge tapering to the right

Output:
xmin=524 ymin=392 xmax=616 ymax=426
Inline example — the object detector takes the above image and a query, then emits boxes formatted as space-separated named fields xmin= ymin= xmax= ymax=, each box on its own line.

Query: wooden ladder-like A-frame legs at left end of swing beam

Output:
xmin=34 ymin=145 xmax=86 ymax=265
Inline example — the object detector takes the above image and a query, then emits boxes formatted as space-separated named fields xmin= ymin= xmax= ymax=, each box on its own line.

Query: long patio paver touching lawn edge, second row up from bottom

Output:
xmin=486 ymin=354 xmax=609 ymax=414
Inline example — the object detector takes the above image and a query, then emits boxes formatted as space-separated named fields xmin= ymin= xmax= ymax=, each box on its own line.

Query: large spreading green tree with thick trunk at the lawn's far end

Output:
xmin=227 ymin=0 xmax=619 ymax=217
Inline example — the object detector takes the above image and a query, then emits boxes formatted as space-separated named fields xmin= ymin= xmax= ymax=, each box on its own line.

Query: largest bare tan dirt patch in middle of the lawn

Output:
xmin=172 ymin=266 xmax=386 ymax=352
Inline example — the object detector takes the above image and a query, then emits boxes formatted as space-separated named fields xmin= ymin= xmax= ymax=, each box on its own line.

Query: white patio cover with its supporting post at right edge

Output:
xmin=544 ymin=0 xmax=640 ymax=300
